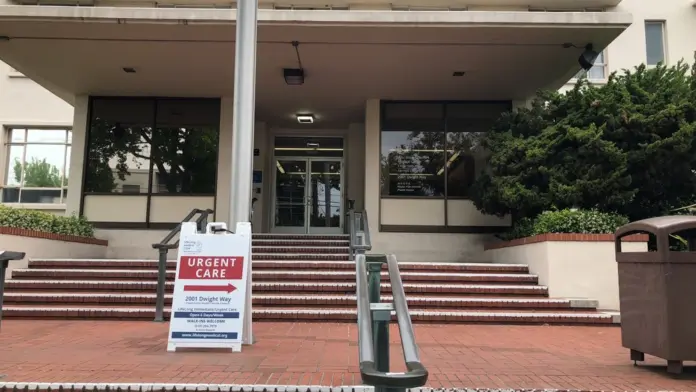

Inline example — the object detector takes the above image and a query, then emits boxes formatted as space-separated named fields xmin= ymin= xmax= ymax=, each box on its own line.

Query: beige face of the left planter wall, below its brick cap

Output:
xmin=0 ymin=234 xmax=107 ymax=279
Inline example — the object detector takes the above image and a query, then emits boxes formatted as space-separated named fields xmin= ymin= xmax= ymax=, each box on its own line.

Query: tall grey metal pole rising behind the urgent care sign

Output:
xmin=229 ymin=0 xmax=259 ymax=228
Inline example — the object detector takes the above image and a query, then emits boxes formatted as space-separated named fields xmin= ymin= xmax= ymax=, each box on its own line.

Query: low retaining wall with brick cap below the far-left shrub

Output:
xmin=0 ymin=227 xmax=109 ymax=279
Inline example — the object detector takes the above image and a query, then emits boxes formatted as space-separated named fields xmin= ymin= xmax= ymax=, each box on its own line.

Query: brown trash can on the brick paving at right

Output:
xmin=615 ymin=215 xmax=696 ymax=373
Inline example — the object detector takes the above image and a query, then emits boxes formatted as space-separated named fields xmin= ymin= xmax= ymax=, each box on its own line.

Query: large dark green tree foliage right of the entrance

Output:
xmin=472 ymin=62 xmax=696 ymax=220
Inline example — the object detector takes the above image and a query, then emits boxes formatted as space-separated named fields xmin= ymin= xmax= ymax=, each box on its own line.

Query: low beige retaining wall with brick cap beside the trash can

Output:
xmin=485 ymin=233 xmax=648 ymax=310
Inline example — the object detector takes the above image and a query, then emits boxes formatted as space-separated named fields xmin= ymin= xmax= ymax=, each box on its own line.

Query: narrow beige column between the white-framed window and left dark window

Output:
xmin=65 ymin=95 xmax=89 ymax=215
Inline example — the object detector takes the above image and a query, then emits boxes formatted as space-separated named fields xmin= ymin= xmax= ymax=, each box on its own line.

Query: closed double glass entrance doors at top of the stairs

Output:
xmin=273 ymin=157 xmax=343 ymax=234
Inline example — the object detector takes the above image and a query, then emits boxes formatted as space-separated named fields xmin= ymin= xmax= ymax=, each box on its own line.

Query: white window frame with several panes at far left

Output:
xmin=0 ymin=125 xmax=73 ymax=209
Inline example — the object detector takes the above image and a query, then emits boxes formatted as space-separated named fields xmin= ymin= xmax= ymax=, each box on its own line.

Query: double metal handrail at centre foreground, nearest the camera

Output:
xmin=355 ymin=254 xmax=428 ymax=391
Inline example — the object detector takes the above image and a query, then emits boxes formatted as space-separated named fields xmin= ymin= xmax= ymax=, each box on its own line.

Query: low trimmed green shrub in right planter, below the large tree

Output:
xmin=501 ymin=209 xmax=628 ymax=240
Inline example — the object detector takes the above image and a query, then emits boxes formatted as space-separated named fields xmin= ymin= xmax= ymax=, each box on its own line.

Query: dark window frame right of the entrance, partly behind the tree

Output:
xmin=378 ymin=100 xmax=512 ymax=203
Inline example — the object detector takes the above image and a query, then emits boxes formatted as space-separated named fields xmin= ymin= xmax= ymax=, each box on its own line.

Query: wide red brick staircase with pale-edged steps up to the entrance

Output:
xmin=3 ymin=234 xmax=615 ymax=324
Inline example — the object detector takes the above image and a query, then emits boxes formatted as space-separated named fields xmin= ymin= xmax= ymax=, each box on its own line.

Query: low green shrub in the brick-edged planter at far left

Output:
xmin=0 ymin=205 xmax=94 ymax=237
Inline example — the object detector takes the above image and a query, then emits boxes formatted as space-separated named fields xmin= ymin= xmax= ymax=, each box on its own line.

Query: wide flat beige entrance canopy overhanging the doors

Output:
xmin=0 ymin=6 xmax=631 ymax=127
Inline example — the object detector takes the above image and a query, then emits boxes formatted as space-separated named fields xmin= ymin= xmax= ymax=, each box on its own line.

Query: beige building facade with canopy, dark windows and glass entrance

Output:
xmin=0 ymin=0 xmax=696 ymax=261
